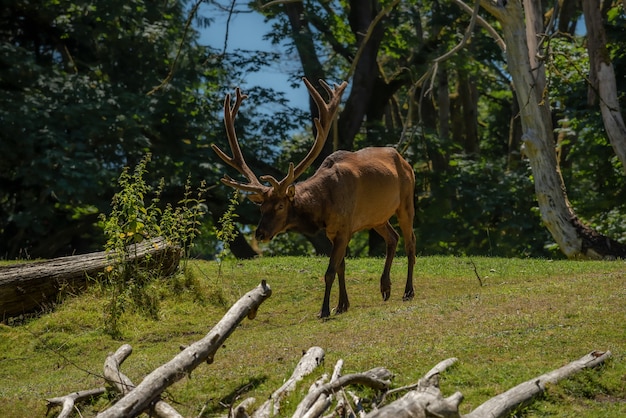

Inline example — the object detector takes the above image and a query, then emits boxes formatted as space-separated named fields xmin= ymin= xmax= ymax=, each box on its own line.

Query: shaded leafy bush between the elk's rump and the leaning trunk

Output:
xmin=416 ymin=156 xmax=555 ymax=257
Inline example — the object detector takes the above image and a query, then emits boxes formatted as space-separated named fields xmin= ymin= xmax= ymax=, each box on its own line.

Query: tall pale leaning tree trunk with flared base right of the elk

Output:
xmin=481 ymin=0 xmax=626 ymax=259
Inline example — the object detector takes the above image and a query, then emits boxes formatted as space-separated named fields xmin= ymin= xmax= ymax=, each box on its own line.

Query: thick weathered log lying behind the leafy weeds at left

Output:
xmin=0 ymin=237 xmax=181 ymax=320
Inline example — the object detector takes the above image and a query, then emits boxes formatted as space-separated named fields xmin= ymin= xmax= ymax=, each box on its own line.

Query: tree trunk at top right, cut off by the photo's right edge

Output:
xmin=582 ymin=0 xmax=626 ymax=173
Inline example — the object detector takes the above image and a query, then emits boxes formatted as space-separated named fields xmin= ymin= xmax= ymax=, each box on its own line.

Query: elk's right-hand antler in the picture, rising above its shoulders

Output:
xmin=261 ymin=77 xmax=348 ymax=194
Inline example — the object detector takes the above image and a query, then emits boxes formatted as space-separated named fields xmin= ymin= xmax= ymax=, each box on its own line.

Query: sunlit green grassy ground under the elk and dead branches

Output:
xmin=0 ymin=257 xmax=626 ymax=418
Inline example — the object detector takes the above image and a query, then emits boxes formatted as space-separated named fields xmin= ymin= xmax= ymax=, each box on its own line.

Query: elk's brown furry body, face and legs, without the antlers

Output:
xmin=252 ymin=148 xmax=415 ymax=318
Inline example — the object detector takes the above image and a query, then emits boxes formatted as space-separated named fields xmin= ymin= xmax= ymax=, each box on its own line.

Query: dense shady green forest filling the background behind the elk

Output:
xmin=0 ymin=0 xmax=626 ymax=259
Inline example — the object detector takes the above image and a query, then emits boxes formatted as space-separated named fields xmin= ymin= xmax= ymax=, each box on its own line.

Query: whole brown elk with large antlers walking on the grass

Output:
xmin=211 ymin=78 xmax=415 ymax=318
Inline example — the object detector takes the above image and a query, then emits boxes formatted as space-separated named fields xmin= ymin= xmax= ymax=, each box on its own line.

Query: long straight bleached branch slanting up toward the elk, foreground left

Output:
xmin=98 ymin=280 xmax=272 ymax=418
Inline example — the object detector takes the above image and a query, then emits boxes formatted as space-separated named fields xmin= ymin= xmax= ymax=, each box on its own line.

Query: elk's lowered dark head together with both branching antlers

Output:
xmin=211 ymin=78 xmax=348 ymax=241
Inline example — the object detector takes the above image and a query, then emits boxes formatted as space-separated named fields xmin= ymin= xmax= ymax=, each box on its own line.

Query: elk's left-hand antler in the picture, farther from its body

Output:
xmin=211 ymin=87 xmax=270 ymax=194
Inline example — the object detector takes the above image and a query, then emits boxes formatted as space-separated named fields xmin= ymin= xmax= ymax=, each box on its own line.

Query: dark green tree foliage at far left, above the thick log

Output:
xmin=0 ymin=0 xmax=222 ymax=258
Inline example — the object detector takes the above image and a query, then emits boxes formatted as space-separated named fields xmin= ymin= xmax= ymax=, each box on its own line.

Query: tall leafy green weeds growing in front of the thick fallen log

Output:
xmin=97 ymin=154 xmax=206 ymax=337
